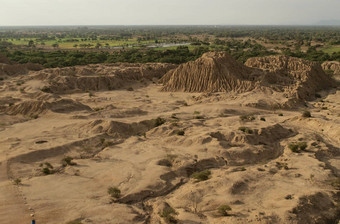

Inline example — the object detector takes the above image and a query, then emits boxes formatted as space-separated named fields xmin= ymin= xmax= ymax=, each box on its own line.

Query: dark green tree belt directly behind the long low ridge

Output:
xmin=1 ymin=47 xmax=209 ymax=67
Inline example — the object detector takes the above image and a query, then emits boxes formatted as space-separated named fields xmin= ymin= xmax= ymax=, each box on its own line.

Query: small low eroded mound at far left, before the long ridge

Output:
xmin=6 ymin=99 xmax=91 ymax=115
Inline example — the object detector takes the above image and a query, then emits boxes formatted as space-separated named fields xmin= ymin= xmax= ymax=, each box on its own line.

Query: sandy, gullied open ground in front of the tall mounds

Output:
xmin=0 ymin=69 xmax=340 ymax=224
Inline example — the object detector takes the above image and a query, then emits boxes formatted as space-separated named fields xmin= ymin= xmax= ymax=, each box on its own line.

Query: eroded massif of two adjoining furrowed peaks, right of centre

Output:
xmin=160 ymin=52 xmax=332 ymax=103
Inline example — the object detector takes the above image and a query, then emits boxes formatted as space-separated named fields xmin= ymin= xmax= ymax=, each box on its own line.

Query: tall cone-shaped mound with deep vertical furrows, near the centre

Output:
xmin=160 ymin=52 xmax=257 ymax=92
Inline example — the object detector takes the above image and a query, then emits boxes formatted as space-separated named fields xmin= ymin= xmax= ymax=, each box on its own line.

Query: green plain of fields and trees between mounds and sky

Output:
xmin=0 ymin=26 xmax=340 ymax=67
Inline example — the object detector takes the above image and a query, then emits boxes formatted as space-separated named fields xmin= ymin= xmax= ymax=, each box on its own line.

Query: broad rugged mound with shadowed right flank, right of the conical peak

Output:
xmin=245 ymin=56 xmax=334 ymax=100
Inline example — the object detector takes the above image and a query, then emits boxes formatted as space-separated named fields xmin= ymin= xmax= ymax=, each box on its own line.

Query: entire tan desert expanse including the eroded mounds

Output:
xmin=0 ymin=52 xmax=340 ymax=224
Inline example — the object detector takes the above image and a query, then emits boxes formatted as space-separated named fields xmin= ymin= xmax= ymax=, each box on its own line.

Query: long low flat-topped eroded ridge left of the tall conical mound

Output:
xmin=33 ymin=63 xmax=175 ymax=93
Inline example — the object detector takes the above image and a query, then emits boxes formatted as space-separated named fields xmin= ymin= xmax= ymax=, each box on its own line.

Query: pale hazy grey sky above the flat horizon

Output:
xmin=0 ymin=0 xmax=340 ymax=26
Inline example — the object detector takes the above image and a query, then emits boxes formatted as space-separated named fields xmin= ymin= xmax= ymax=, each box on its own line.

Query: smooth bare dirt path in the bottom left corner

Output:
xmin=0 ymin=161 xmax=31 ymax=224
